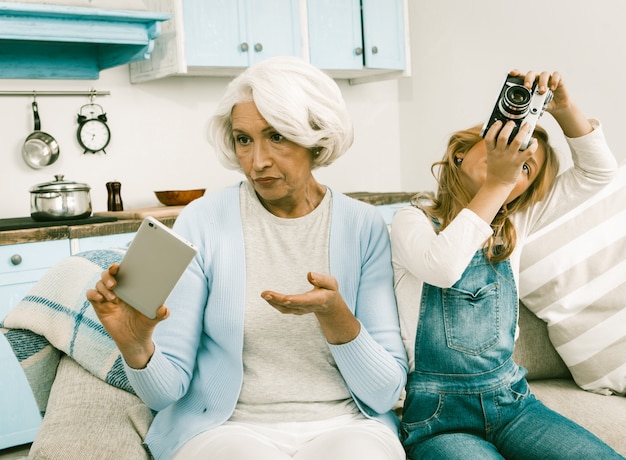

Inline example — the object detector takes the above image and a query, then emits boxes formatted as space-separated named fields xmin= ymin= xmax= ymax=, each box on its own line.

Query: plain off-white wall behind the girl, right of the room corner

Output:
xmin=399 ymin=0 xmax=626 ymax=190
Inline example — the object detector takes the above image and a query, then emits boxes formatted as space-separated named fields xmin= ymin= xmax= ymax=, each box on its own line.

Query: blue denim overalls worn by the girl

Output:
xmin=401 ymin=246 xmax=623 ymax=460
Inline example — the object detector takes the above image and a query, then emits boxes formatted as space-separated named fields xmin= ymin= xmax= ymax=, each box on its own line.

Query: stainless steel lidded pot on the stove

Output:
xmin=30 ymin=175 xmax=91 ymax=220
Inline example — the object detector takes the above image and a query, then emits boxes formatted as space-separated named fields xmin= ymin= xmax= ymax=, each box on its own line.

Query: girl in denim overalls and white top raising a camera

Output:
xmin=391 ymin=71 xmax=623 ymax=460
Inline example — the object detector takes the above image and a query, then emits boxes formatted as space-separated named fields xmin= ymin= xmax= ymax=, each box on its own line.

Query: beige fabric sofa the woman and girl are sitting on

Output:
xmin=4 ymin=298 xmax=626 ymax=460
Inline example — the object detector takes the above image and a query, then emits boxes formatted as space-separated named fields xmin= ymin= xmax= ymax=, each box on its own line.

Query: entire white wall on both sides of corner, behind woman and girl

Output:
xmin=0 ymin=0 xmax=626 ymax=218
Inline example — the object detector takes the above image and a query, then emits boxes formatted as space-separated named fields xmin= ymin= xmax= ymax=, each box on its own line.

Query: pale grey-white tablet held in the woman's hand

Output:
xmin=115 ymin=217 xmax=197 ymax=318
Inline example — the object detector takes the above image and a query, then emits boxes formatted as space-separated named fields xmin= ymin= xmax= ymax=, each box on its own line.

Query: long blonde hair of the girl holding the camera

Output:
xmin=412 ymin=125 xmax=559 ymax=262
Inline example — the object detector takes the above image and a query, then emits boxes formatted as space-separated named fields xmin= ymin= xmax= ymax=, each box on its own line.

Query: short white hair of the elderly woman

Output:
xmin=209 ymin=56 xmax=354 ymax=171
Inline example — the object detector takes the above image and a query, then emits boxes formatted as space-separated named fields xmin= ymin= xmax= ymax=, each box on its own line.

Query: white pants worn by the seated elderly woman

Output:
xmin=172 ymin=415 xmax=406 ymax=460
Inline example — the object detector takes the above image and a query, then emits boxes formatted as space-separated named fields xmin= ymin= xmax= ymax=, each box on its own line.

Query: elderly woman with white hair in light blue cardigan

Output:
xmin=87 ymin=58 xmax=407 ymax=460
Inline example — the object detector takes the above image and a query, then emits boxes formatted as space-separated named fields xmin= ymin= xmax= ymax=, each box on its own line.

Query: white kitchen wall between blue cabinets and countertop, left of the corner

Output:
xmin=0 ymin=66 xmax=400 ymax=218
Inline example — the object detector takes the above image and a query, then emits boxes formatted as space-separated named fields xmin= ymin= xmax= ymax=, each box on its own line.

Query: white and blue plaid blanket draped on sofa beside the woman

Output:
xmin=0 ymin=249 xmax=129 ymax=414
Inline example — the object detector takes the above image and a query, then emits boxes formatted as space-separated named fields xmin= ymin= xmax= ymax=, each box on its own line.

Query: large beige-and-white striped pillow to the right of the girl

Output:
xmin=520 ymin=164 xmax=626 ymax=395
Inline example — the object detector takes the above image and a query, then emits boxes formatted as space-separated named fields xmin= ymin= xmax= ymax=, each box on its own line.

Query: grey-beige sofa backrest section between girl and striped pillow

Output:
xmin=513 ymin=302 xmax=572 ymax=380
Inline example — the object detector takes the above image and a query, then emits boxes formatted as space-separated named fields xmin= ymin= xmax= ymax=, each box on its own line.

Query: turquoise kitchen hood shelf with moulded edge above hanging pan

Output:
xmin=0 ymin=2 xmax=171 ymax=80
